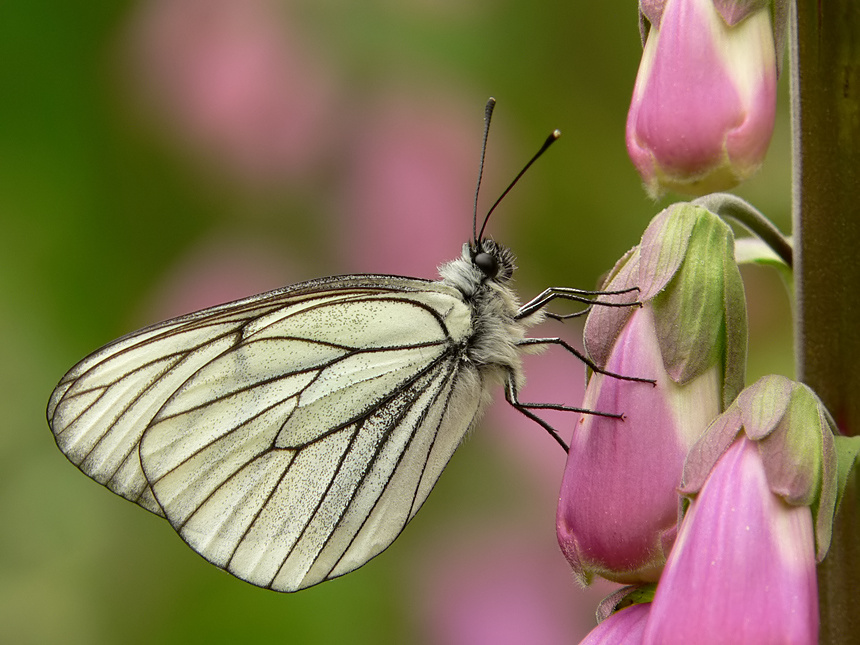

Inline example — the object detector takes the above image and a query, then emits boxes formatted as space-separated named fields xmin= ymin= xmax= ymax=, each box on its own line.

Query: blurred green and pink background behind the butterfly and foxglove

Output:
xmin=0 ymin=0 xmax=792 ymax=644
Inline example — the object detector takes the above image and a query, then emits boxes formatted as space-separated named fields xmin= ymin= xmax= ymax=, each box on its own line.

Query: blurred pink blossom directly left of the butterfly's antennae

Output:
xmin=338 ymin=92 xmax=484 ymax=278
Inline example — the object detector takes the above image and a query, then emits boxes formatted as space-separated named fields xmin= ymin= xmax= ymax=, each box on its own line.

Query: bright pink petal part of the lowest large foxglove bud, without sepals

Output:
xmin=642 ymin=435 xmax=818 ymax=645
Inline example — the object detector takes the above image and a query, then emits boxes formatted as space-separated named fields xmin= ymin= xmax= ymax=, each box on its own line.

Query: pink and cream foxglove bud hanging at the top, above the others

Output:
xmin=627 ymin=0 xmax=787 ymax=197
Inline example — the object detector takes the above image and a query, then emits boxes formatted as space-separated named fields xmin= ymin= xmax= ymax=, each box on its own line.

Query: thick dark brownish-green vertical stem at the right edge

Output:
xmin=789 ymin=0 xmax=860 ymax=644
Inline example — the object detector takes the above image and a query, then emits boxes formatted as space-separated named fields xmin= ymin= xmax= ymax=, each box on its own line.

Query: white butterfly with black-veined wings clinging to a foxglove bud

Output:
xmin=47 ymin=100 xmax=640 ymax=591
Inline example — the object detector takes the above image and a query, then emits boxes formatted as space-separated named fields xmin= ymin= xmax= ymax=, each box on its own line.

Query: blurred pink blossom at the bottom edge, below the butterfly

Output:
xmin=416 ymin=524 xmax=609 ymax=645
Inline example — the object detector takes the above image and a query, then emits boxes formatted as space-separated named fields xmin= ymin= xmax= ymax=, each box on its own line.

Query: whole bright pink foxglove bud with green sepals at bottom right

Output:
xmin=643 ymin=376 xmax=857 ymax=645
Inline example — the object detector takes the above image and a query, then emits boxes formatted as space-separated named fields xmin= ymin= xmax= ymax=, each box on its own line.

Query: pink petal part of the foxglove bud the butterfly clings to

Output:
xmin=557 ymin=304 xmax=722 ymax=582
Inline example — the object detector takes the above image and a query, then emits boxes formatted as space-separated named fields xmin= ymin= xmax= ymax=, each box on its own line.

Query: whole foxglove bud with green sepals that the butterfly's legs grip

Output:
xmin=556 ymin=204 xmax=746 ymax=583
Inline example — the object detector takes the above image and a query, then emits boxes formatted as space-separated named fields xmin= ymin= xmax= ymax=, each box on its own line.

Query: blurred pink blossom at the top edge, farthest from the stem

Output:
xmin=129 ymin=0 xmax=334 ymax=185
